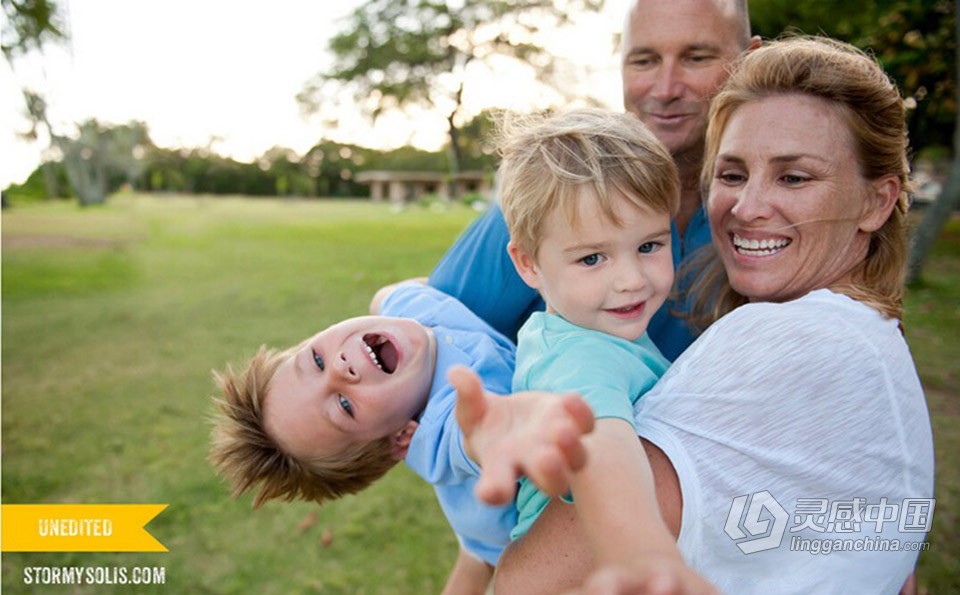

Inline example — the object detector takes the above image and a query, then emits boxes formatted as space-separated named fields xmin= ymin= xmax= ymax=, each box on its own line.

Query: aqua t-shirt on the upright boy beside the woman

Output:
xmin=510 ymin=312 xmax=670 ymax=539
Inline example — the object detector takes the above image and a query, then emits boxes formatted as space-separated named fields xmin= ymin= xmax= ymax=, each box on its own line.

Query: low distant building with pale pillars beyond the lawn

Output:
xmin=354 ymin=170 xmax=490 ymax=203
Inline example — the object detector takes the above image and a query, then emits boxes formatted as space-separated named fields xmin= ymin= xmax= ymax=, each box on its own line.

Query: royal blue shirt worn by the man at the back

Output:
xmin=428 ymin=205 xmax=710 ymax=361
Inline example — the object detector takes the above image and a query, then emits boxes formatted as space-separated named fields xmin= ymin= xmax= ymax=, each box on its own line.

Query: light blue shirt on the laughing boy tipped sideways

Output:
xmin=380 ymin=283 xmax=517 ymax=565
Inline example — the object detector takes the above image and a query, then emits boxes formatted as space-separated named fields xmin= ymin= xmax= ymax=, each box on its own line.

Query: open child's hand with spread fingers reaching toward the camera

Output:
xmin=447 ymin=366 xmax=593 ymax=504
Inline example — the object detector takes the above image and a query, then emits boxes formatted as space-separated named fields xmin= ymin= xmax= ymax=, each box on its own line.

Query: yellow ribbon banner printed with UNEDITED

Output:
xmin=0 ymin=504 xmax=167 ymax=552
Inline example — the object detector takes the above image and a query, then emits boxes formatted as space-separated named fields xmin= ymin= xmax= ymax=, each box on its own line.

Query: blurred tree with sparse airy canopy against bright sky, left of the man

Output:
xmin=298 ymin=0 xmax=603 ymax=173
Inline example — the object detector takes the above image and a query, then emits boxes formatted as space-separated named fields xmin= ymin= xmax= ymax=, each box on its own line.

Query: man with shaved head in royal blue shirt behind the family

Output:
xmin=429 ymin=0 xmax=760 ymax=361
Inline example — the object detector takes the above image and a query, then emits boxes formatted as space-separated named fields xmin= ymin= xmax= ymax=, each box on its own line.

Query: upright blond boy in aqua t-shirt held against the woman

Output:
xmin=500 ymin=109 xmax=679 ymax=539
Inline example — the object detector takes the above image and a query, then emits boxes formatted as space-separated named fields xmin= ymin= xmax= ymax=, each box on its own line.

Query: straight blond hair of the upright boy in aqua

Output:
xmin=500 ymin=108 xmax=680 ymax=257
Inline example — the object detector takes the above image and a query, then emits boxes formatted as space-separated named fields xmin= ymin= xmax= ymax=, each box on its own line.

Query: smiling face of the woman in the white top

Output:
xmin=707 ymin=95 xmax=873 ymax=301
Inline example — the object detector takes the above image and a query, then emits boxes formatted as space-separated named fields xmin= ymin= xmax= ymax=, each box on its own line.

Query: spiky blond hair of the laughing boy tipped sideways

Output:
xmin=210 ymin=347 xmax=397 ymax=508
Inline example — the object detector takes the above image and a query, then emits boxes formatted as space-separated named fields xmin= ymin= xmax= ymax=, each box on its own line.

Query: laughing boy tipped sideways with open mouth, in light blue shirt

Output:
xmin=211 ymin=282 xmax=516 ymax=593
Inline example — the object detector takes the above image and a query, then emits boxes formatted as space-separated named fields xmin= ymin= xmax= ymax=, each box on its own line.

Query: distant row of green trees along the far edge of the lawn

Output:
xmin=4 ymin=118 xmax=494 ymax=205
